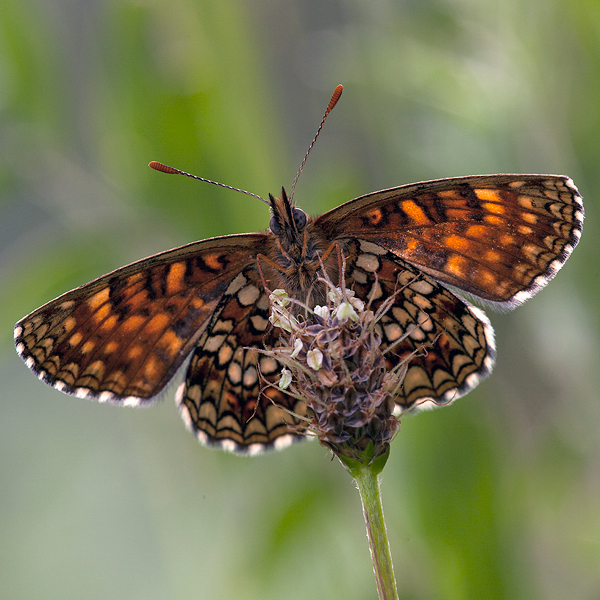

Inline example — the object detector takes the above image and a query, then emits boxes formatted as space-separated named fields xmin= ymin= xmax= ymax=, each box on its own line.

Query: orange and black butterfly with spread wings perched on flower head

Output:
xmin=15 ymin=86 xmax=583 ymax=454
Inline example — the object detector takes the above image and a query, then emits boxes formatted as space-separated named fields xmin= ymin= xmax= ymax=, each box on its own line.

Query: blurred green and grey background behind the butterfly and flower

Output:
xmin=0 ymin=0 xmax=600 ymax=600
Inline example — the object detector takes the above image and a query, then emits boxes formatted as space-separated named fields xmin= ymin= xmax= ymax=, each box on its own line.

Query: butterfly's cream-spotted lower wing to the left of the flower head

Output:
xmin=177 ymin=267 xmax=306 ymax=454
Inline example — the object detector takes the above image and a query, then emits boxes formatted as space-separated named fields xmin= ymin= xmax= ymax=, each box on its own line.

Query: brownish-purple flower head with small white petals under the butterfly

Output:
xmin=265 ymin=281 xmax=406 ymax=464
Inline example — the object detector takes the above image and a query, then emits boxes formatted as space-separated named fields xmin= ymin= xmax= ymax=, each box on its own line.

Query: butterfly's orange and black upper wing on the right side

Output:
xmin=315 ymin=175 xmax=583 ymax=309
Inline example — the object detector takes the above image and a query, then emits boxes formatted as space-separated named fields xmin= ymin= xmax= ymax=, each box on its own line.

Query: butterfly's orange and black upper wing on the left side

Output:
xmin=15 ymin=234 xmax=266 ymax=405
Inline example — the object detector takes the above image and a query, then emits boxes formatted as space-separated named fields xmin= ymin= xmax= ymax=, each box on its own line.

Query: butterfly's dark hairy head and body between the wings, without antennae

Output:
xmin=269 ymin=188 xmax=338 ymax=307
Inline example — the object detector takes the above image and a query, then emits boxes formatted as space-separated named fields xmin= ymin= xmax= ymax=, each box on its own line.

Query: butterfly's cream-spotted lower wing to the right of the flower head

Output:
xmin=346 ymin=239 xmax=495 ymax=410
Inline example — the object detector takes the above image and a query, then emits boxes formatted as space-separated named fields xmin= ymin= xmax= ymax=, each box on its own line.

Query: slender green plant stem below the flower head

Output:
xmin=349 ymin=464 xmax=398 ymax=600
